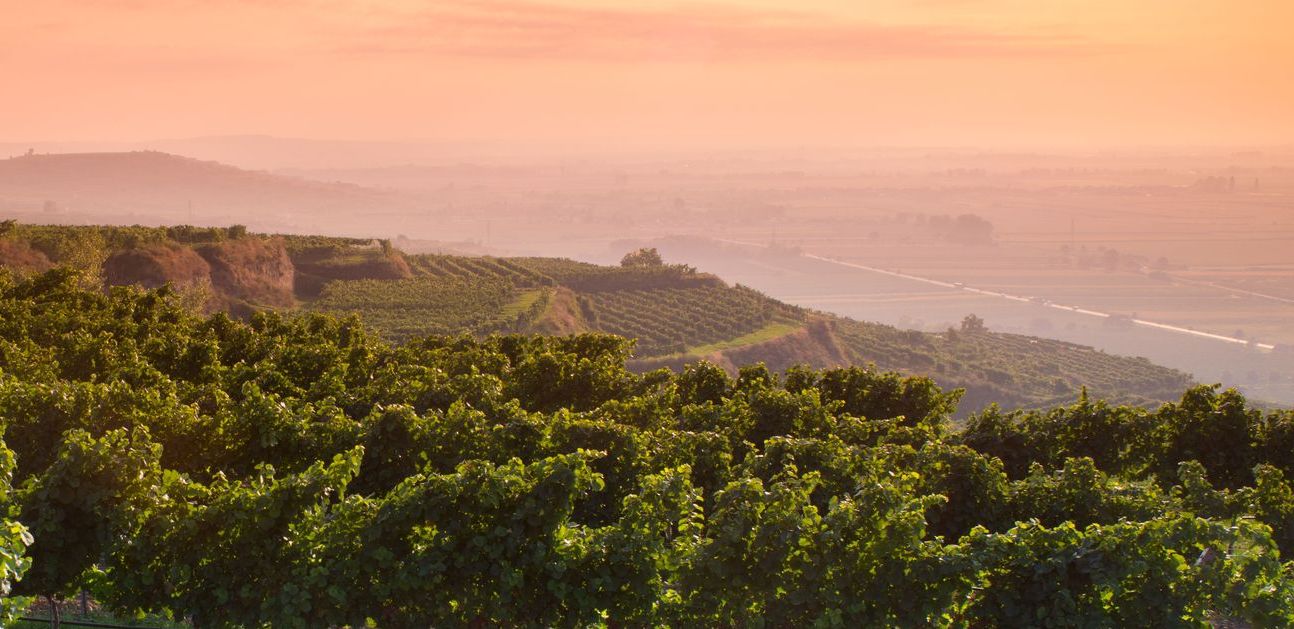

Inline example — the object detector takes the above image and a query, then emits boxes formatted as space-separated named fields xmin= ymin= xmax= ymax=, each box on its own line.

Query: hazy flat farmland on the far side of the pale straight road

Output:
xmin=709 ymin=181 xmax=1294 ymax=344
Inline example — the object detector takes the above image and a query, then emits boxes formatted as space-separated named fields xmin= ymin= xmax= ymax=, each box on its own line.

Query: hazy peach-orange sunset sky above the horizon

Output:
xmin=0 ymin=0 xmax=1294 ymax=148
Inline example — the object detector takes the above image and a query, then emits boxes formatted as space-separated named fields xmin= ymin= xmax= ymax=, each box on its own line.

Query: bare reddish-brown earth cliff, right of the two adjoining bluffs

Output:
xmin=197 ymin=238 xmax=296 ymax=307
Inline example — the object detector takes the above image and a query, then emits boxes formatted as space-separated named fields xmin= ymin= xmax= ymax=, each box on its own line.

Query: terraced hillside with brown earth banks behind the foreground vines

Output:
xmin=0 ymin=224 xmax=1190 ymax=413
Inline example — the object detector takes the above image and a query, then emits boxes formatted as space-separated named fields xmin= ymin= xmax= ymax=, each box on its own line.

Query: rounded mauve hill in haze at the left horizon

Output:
xmin=0 ymin=151 xmax=408 ymax=229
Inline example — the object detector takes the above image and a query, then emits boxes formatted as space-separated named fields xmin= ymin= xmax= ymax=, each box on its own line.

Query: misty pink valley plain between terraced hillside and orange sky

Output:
xmin=0 ymin=144 xmax=1294 ymax=404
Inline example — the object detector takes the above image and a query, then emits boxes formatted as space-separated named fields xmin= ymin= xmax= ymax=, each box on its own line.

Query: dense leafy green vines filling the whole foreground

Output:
xmin=0 ymin=269 xmax=1294 ymax=628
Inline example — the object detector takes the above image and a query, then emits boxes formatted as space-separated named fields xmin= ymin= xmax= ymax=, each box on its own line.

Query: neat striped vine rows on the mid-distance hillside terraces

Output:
xmin=297 ymin=245 xmax=805 ymax=356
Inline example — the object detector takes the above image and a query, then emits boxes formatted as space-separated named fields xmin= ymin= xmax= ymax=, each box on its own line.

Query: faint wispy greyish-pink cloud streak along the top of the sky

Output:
xmin=336 ymin=0 xmax=1110 ymax=61
